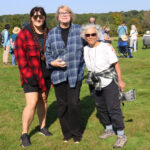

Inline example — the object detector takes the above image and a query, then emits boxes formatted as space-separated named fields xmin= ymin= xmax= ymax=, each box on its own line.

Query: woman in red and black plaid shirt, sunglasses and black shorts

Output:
xmin=15 ymin=7 xmax=52 ymax=147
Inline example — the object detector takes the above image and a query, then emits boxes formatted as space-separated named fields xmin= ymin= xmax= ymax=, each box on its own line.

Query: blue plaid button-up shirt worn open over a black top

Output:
xmin=45 ymin=24 xmax=85 ymax=88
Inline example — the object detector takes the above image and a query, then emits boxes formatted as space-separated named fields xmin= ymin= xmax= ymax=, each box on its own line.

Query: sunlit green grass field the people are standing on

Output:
xmin=0 ymin=38 xmax=150 ymax=150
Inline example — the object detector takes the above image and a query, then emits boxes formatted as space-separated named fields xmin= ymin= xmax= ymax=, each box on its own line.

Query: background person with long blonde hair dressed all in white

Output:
xmin=130 ymin=25 xmax=138 ymax=52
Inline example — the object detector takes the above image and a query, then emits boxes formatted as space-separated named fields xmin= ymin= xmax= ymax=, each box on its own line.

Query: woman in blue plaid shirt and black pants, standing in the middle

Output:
xmin=45 ymin=6 xmax=85 ymax=143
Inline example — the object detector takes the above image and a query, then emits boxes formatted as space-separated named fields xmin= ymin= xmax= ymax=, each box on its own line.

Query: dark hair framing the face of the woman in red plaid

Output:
xmin=30 ymin=7 xmax=47 ymax=29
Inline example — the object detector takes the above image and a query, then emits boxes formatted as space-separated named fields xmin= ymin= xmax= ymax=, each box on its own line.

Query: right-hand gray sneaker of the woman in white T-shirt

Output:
xmin=113 ymin=135 xmax=127 ymax=148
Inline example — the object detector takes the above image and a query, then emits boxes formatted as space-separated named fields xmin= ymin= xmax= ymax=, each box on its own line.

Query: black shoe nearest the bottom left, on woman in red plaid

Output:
xmin=20 ymin=133 xmax=31 ymax=147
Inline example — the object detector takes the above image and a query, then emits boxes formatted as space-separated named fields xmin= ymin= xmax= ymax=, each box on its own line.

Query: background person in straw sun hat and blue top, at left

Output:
xmin=10 ymin=27 xmax=20 ymax=66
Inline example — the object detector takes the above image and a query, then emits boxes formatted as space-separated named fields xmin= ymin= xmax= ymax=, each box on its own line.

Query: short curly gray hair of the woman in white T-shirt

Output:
xmin=81 ymin=23 xmax=101 ymax=39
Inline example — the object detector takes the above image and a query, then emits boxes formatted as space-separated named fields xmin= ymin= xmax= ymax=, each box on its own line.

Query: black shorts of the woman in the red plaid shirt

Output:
xmin=22 ymin=78 xmax=51 ymax=93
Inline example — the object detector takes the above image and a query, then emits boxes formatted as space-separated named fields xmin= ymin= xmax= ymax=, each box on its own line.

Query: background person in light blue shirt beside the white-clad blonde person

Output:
xmin=117 ymin=21 xmax=128 ymax=40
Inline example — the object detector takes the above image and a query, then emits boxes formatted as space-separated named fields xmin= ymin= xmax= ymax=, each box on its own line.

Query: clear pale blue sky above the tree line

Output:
xmin=0 ymin=0 xmax=150 ymax=16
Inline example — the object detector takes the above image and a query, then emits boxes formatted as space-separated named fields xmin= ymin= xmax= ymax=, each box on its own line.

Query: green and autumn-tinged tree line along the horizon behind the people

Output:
xmin=0 ymin=10 xmax=150 ymax=36
